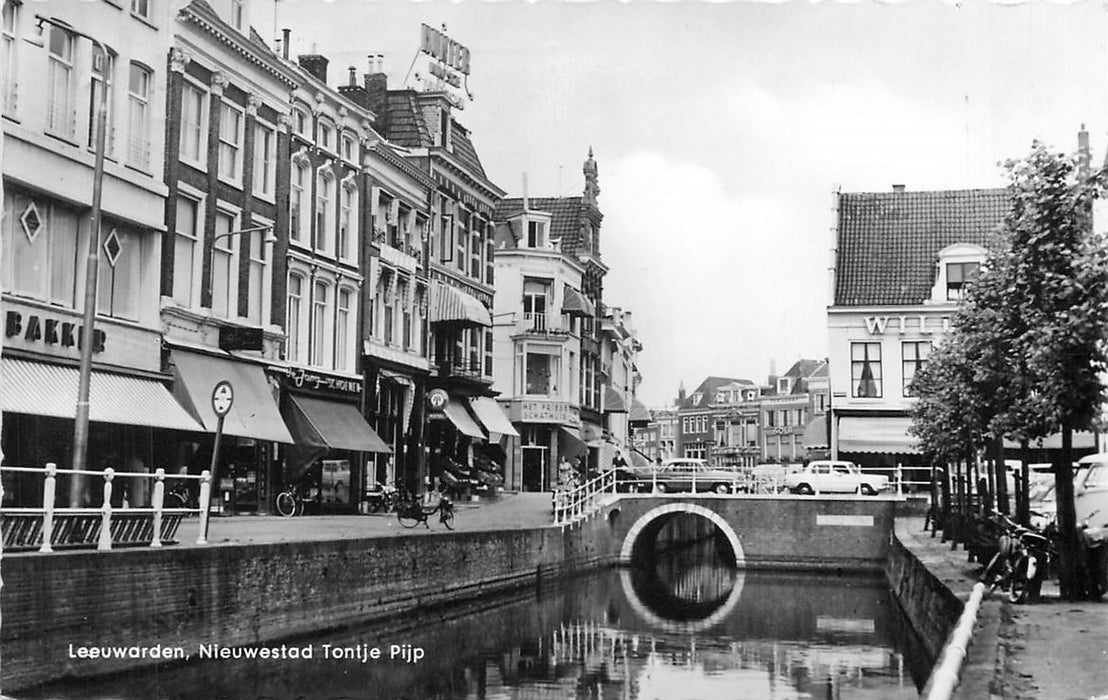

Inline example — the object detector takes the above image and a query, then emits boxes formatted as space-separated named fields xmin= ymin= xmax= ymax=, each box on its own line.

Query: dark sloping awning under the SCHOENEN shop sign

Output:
xmin=286 ymin=395 xmax=392 ymax=452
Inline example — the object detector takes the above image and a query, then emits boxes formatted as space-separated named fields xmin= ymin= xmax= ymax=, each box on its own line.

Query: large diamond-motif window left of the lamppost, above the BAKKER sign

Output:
xmin=0 ymin=188 xmax=81 ymax=308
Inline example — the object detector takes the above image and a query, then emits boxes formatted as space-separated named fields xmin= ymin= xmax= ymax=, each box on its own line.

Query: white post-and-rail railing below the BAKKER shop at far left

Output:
xmin=0 ymin=463 xmax=212 ymax=553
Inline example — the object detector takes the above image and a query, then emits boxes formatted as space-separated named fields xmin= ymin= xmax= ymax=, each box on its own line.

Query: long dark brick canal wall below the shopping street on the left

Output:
xmin=0 ymin=518 xmax=612 ymax=693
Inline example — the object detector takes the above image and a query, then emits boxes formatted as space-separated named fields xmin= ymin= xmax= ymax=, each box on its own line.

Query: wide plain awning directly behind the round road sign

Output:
xmin=166 ymin=350 xmax=294 ymax=444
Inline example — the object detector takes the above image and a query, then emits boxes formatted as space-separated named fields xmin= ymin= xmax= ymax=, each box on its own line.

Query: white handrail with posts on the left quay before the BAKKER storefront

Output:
xmin=0 ymin=462 xmax=212 ymax=554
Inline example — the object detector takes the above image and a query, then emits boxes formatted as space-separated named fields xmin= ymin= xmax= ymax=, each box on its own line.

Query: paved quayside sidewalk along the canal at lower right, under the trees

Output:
xmin=896 ymin=517 xmax=1108 ymax=700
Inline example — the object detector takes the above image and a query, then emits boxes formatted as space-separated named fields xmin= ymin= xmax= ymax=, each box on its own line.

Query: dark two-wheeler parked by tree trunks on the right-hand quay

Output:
xmin=981 ymin=514 xmax=1055 ymax=603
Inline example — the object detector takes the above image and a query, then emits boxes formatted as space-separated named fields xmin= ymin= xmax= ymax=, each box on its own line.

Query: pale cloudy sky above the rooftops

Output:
xmin=265 ymin=0 xmax=1108 ymax=406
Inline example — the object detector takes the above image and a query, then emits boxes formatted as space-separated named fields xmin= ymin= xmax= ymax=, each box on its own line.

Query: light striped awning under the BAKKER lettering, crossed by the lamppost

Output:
xmin=0 ymin=358 xmax=204 ymax=432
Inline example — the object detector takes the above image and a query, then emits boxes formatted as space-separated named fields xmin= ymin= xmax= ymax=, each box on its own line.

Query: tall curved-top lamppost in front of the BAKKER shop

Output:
xmin=34 ymin=14 xmax=109 ymax=480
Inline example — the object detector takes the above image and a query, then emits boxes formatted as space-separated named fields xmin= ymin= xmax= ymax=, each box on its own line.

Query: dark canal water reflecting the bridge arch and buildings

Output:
xmin=17 ymin=513 xmax=930 ymax=700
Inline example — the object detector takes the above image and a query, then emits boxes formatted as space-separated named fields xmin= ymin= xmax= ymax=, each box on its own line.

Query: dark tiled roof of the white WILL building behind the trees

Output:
xmin=834 ymin=189 xmax=1008 ymax=306
